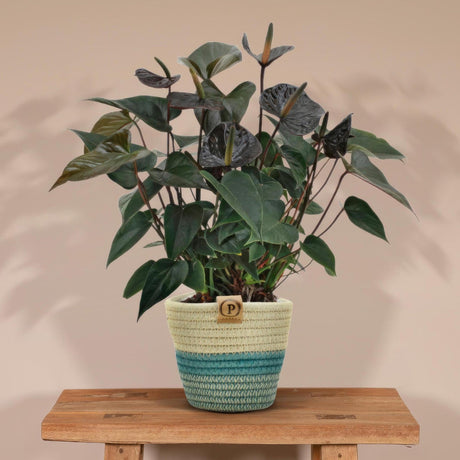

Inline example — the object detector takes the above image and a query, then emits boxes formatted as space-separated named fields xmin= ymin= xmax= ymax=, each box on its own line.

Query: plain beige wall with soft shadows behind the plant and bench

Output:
xmin=0 ymin=0 xmax=460 ymax=460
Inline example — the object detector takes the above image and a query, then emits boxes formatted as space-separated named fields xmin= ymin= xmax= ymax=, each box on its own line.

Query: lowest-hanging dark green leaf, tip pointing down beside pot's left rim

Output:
xmin=137 ymin=259 xmax=188 ymax=320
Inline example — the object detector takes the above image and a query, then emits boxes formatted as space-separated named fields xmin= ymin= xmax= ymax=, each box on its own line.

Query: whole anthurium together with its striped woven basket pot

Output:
xmin=52 ymin=24 xmax=410 ymax=412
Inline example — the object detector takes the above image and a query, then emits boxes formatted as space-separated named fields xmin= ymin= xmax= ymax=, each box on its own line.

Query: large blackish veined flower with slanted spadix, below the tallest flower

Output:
xmin=260 ymin=83 xmax=324 ymax=136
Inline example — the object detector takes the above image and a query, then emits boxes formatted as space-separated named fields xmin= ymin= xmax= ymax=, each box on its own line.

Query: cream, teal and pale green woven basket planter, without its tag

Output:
xmin=166 ymin=295 xmax=292 ymax=412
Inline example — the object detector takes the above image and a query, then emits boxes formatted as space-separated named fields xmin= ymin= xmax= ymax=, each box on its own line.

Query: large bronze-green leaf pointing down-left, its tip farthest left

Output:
xmin=51 ymin=131 xmax=151 ymax=190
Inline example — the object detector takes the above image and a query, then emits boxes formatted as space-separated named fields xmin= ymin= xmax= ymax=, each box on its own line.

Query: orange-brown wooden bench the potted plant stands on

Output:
xmin=42 ymin=388 xmax=419 ymax=460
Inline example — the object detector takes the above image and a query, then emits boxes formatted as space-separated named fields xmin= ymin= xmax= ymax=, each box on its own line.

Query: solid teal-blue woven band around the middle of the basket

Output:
xmin=176 ymin=350 xmax=285 ymax=375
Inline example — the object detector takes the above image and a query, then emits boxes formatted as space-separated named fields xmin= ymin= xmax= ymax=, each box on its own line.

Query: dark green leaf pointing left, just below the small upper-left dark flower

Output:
xmin=89 ymin=96 xmax=181 ymax=132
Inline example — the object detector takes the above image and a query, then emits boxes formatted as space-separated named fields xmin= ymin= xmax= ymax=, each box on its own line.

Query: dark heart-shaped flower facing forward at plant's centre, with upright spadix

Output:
xmin=200 ymin=122 xmax=262 ymax=168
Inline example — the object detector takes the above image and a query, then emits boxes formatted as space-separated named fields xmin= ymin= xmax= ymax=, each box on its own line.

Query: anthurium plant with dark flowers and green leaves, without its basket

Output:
xmin=52 ymin=24 xmax=411 ymax=317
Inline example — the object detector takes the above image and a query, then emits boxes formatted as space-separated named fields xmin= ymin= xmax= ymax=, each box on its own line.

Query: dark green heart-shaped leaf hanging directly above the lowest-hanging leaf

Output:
xmin=164 ymin=203 xmax=203 ymax=259
